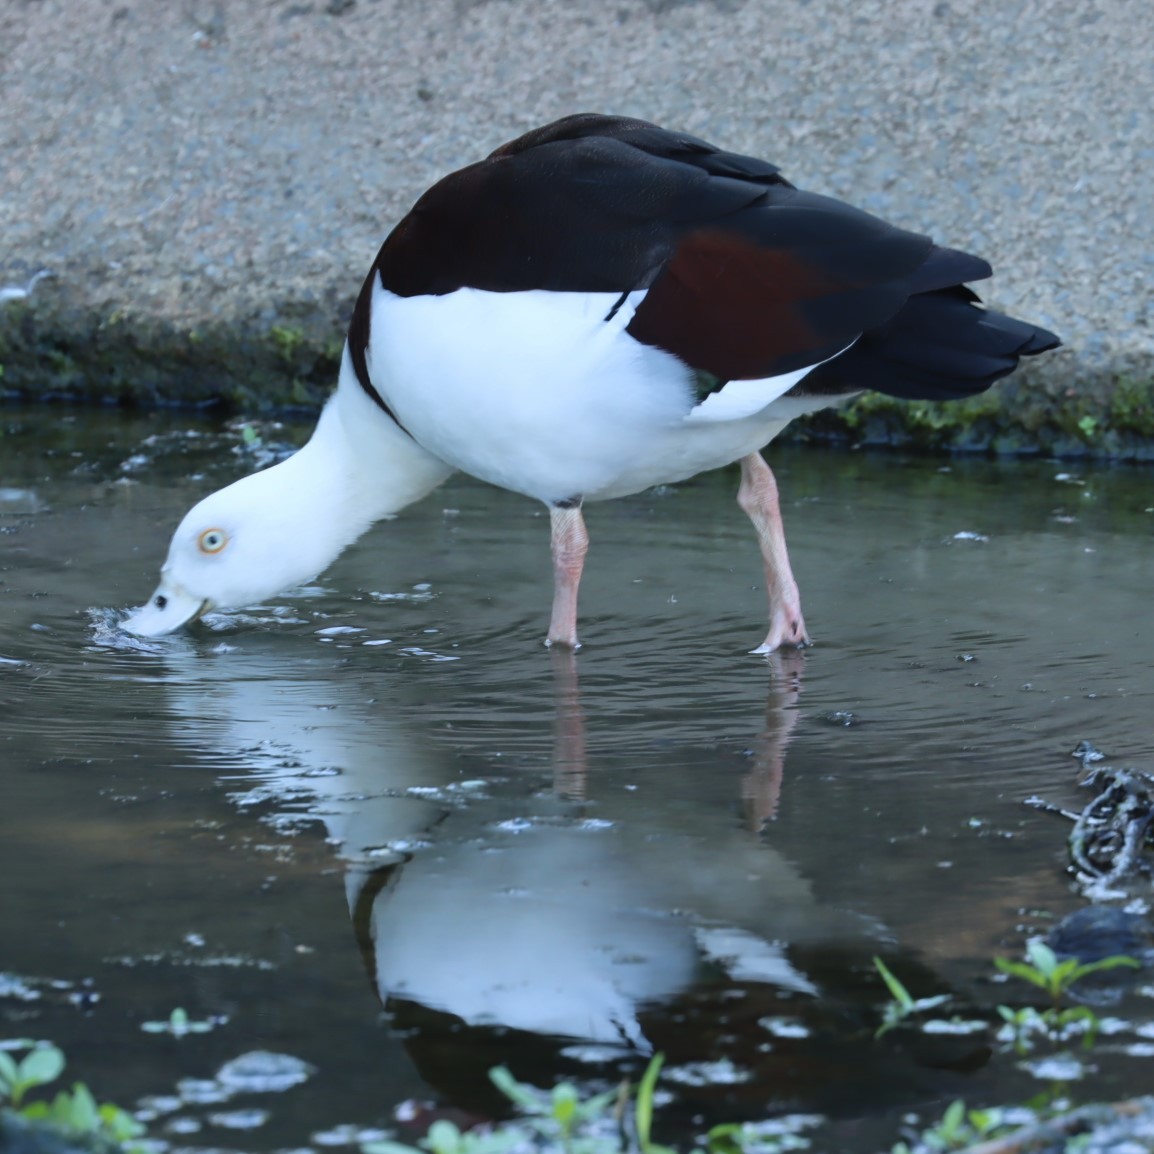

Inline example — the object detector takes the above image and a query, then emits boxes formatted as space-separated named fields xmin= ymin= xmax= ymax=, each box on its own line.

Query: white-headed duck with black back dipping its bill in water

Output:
xmin=126 ymin=114 xmax=1059 ymax=652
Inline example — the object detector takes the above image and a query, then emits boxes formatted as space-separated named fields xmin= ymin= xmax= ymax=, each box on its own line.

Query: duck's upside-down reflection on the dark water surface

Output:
xmin=155 ymin=653 xmax=983 ymax=1109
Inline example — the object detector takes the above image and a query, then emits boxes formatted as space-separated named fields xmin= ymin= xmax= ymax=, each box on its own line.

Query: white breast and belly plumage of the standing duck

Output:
xmin=367 ymin=285 xmax=835 ymax=502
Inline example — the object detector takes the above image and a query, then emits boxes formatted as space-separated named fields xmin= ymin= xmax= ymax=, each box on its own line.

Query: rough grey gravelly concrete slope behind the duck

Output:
xmin=0 ymin=0 xmax=1154 ymax=401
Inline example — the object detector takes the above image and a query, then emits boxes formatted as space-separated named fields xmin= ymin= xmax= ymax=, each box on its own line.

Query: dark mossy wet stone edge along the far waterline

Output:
xmin=0 ymin=299 xmax=1154 ymax=462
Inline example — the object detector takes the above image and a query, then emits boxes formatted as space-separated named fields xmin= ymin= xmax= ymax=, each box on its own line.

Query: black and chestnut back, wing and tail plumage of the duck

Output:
xmin=350 ymin=114 xmax=1059 ymax=398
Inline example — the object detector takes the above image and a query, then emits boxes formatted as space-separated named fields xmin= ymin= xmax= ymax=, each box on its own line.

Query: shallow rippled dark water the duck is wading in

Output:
xmin=0 ymin=410 xmax=1154 ymax=1151
